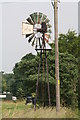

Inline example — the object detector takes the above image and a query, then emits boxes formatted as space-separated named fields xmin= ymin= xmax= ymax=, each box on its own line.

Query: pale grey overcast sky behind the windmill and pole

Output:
xmin=0 ymin=0 xmax=78 ymax=73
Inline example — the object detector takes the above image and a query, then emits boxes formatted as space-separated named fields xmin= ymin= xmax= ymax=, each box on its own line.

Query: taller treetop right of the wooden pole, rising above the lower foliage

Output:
xmin=59 ymin=30 xmax=79 ymax=57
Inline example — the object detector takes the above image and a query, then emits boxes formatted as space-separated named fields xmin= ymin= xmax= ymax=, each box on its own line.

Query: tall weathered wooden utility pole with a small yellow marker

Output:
xmin=54 ymin=0 xmax=60 ymax=112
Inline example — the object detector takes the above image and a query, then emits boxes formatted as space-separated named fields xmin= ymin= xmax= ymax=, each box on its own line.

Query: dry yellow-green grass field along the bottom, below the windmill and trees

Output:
xmin=2 ymin=101 xmax=78 ymax=118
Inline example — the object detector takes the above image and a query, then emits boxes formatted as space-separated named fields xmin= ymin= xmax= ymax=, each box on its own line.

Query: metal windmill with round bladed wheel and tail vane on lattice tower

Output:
xmin=22 ymin=12 xmax=51 ymax=105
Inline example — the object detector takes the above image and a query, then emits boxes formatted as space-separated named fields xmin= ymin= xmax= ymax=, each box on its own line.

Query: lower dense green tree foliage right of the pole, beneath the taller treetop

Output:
xmin=60 ymin=53 xmax=78 ymax=106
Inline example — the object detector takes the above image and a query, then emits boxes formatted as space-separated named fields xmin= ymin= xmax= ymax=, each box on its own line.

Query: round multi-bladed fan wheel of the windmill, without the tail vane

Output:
xmin=26 ymin=12 xmax=52 ymax=48
